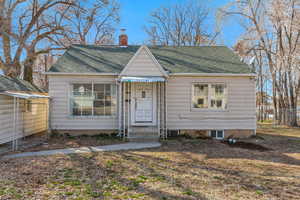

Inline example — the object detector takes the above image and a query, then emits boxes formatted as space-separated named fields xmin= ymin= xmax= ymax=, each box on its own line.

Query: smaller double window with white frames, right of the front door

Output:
xmin=192 ymin=83 xmax=227 ymax=109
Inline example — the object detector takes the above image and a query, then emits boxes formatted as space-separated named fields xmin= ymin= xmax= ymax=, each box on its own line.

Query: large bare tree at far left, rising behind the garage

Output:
xmin=0 ymin=0 xmax=73 ymax=81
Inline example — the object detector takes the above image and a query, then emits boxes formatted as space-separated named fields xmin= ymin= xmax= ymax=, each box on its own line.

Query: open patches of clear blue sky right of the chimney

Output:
xmin=119 ymin=0 xmax=242 ymax=47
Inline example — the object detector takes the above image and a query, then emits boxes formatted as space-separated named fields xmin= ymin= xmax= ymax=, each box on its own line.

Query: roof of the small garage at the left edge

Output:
xmin=0 ymin=75 xmax=44 ymax=92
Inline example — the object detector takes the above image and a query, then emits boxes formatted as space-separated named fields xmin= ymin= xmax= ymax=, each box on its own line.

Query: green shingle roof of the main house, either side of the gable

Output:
xmin=49 ymin=45 xmax=251 ymax=74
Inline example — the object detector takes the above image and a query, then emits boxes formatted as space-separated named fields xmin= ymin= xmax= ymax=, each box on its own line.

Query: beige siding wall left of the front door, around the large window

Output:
xmin=49 ymin=76 xmax=118 ymax=130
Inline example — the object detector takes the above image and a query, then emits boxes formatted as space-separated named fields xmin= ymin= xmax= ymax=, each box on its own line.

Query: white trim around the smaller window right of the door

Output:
xmin=190 ymin=82 xmax=229 ymax=112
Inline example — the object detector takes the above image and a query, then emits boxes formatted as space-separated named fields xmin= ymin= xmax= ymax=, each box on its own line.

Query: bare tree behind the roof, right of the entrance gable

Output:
xmin=145 ymin=1 xmax=219 ymax=46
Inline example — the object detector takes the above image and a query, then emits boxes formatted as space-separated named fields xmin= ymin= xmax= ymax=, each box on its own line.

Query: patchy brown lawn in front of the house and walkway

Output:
xmin=0 ymin=125 xmax=300 ymax=200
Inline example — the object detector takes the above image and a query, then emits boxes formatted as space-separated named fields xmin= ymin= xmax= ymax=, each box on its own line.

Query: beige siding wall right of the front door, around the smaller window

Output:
xmin=167 ymin=76 xmax=256 ymax=130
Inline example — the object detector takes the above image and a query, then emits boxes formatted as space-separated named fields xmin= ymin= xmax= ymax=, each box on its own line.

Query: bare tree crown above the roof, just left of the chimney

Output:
xmin=61 ymin=0 xmax=120 ymax=45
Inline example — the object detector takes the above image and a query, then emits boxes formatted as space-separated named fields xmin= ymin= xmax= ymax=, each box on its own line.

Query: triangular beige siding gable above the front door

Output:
xmin=122 ymin=49 xmax=162 ymax=76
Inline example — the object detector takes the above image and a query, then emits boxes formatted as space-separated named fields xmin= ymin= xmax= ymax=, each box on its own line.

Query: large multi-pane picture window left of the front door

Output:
xmin=71 ymin=83 xmax=116 ymax=116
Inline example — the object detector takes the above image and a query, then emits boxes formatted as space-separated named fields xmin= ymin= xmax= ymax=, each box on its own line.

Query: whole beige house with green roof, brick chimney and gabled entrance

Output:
xmin=47 ymin=35 xmax=256 ymax=139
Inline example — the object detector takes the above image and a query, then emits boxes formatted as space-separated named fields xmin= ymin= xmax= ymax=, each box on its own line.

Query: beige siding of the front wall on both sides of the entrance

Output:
xmin=49 ymin=75 xmax=256 ymax=130
